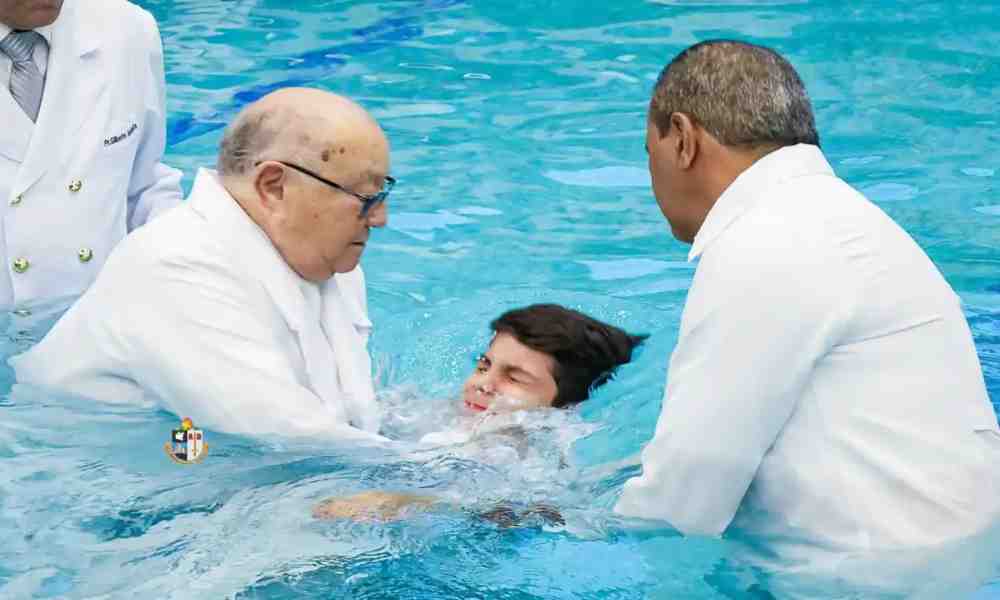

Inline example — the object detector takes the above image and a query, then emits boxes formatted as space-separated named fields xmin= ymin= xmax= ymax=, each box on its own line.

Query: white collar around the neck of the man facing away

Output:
xmin=688 ymin=144 xmax=834 ymax=261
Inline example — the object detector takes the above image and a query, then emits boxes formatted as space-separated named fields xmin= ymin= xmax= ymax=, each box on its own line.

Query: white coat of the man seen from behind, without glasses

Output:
xmin=616 ymin=145 xmax=1000 ymax=561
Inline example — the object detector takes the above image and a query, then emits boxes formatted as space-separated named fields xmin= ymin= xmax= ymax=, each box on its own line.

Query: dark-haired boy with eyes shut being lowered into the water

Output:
xmin=313 ymin=304 xmax=646 ymax=524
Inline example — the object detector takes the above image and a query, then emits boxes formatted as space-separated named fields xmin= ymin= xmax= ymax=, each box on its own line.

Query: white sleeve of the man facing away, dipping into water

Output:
xmin=615 ymin=239 xmax=846 ymax=535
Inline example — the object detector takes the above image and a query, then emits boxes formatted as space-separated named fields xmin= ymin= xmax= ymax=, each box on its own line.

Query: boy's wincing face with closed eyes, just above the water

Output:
xmin=462 ymin=333 xmax=558 ymax=412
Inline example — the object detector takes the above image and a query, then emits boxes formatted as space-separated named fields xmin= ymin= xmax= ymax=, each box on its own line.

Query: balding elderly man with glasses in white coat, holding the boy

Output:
xmin=11 ymin=89 xmax=395 ymax=440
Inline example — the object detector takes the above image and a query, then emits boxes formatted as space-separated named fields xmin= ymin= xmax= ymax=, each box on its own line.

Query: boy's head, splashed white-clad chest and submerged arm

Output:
xmin=313 ymin=304 xmax=645 ymax=526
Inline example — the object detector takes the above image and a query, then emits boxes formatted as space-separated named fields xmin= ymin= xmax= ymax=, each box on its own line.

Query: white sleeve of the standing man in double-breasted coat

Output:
xmin=128 ymin=10 xmax=182 ymax=231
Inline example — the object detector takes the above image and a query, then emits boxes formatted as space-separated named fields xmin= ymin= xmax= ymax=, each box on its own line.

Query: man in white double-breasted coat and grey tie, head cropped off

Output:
xmin=0 ymin=0 xmax=181 ymax=314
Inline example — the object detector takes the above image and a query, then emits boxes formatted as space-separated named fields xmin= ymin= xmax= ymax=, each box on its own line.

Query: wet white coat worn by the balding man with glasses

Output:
xmin=10 ymin=170 xmax=380 ymax=446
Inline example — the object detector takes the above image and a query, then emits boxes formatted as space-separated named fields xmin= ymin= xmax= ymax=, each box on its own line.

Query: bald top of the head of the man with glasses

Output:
xmin=218 ymin=88 xmax=386 ymax=177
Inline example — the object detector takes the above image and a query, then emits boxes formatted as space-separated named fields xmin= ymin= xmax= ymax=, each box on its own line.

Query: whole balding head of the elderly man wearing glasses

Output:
xmin=218 ymin=88 xmax=389 ymax=282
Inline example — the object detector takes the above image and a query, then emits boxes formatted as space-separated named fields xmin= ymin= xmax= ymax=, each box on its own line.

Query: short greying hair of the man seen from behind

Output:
xmin=649 ymin=40 xmax=819 ymax=150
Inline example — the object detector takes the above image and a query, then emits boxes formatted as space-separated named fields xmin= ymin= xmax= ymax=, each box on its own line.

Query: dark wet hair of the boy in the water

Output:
xmin=490 ymin=304 xmax=648 ymax=408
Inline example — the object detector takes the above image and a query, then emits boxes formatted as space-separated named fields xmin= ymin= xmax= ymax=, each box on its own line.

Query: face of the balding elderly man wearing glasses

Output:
xmin=280 ymin=130 xmax=389 ymax=282
